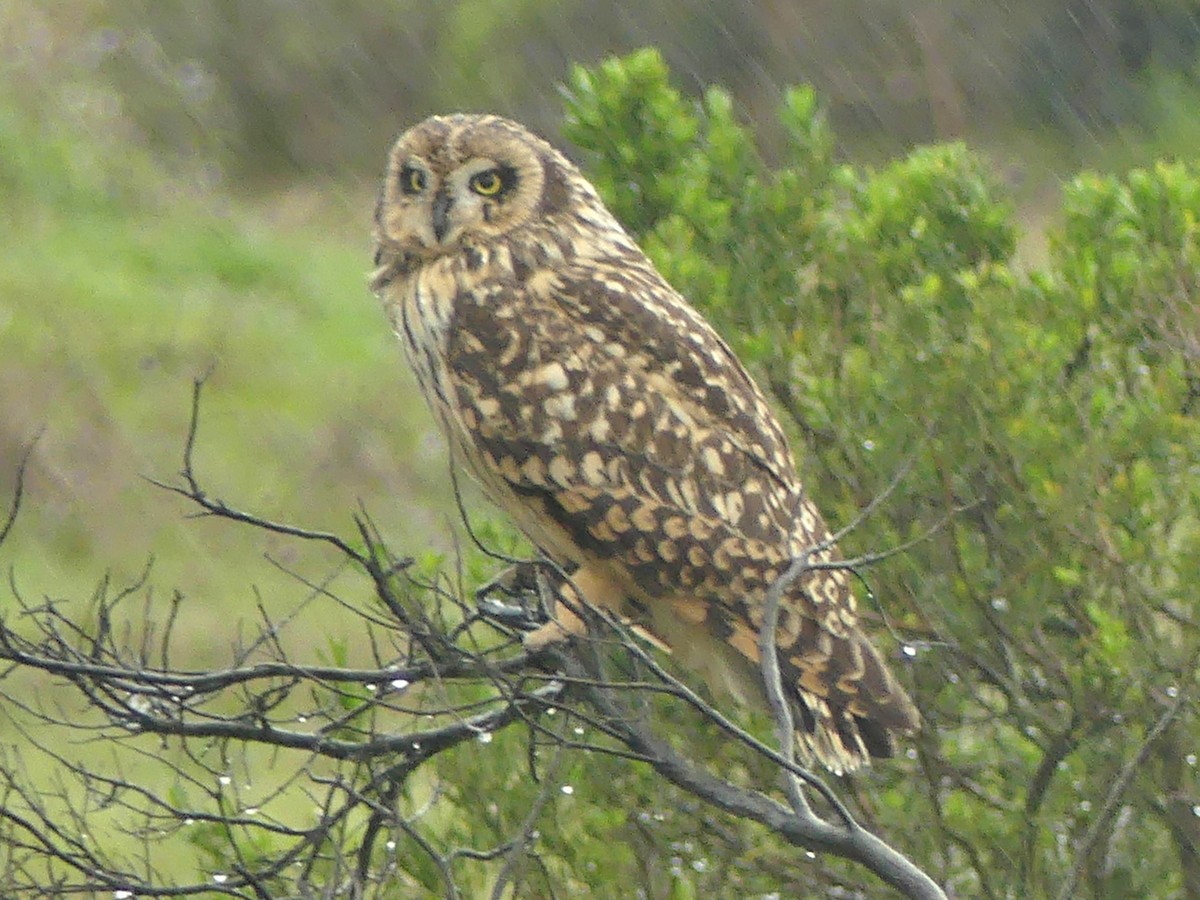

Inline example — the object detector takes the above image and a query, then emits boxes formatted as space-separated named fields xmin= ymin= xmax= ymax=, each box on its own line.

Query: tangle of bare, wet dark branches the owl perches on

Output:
xmin=0 ymin=379 xmax=943 ymax=898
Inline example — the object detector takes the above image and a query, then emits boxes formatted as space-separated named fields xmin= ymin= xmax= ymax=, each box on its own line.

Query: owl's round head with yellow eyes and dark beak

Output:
xmin=376 ymin=115 xmax=585 ymax=259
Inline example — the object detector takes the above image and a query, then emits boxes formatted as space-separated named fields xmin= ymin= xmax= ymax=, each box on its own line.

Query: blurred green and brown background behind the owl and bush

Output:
xmin=0 ymin=0 xmax=1200 ymax=897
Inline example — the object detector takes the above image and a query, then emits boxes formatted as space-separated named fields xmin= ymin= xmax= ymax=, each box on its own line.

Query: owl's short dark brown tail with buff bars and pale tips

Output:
xmin=779 ymin=629 xmax=920 ymax=775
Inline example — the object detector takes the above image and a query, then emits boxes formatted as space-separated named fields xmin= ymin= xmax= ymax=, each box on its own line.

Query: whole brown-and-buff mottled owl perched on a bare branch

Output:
xmin=372 ymin=115 xmax=919 ymax=773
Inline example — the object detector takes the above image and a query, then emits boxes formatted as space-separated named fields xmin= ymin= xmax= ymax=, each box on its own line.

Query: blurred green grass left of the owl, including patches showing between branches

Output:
xmin=0 ymin=84 xmax=477 ymax=877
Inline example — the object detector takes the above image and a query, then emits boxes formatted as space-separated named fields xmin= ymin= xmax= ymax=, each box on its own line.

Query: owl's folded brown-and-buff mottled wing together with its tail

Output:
xmin=449 ymin=260 xmax=917 ymax=770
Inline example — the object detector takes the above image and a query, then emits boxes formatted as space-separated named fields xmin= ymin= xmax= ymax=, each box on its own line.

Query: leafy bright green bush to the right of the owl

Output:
xmin=565 ymin=52 xmax=1200 ymax=896
